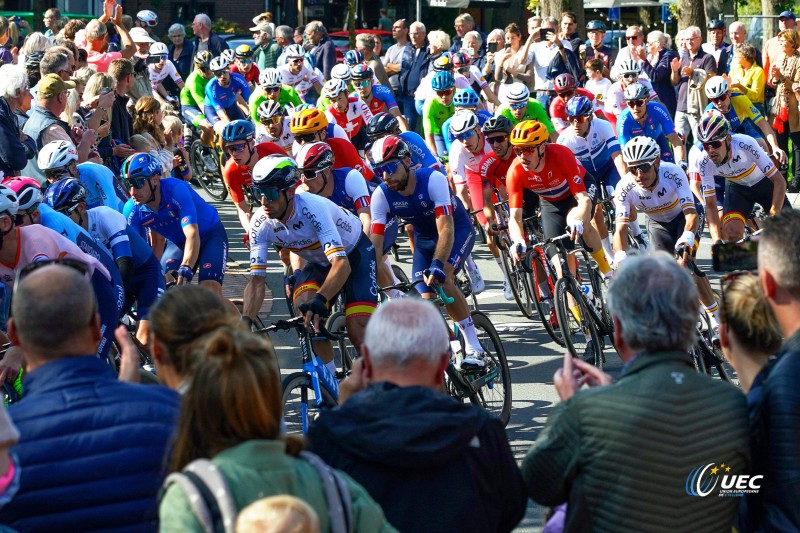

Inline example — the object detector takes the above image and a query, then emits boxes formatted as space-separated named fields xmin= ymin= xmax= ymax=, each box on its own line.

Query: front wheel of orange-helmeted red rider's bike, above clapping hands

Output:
xmin=555 ymin=277 xmax=603 ymax=368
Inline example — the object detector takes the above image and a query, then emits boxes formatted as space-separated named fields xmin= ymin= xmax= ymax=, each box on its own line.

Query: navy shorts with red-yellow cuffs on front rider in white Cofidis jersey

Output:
xmin=293 ymin=235 xmax=378 ymax=318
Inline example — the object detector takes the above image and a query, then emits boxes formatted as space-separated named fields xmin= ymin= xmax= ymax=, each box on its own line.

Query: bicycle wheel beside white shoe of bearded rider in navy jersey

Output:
xmin=465 ymin=311 xmax=511 ymax=426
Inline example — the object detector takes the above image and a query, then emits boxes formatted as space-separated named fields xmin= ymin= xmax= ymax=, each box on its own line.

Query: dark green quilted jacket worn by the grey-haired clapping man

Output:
xmin=522 ymin=352 xmax=750 ymax=533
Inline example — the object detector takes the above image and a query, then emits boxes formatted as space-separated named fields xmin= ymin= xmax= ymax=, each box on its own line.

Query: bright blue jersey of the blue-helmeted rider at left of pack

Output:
xmin=122 ymin=178 xmax=220 ymax=246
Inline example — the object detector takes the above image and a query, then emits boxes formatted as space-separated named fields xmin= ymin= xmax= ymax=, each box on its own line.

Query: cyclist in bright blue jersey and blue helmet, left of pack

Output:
xmin=122 ymin=153 xmax=228 ymax=297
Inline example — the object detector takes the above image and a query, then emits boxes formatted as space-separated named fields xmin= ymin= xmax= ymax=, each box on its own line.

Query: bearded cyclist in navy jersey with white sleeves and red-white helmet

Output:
xmin=370 ymin=135 xmax=485 ymax=372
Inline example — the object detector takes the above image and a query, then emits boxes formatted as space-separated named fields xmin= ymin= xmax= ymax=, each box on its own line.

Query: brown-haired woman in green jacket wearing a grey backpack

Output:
xmin=159 ymin=326 xmax=389 ymax=532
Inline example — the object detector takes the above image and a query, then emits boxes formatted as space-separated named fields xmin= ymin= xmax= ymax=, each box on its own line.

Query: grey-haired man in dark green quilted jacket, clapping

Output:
xmin=522 ymin=253 xmax=750 ymax=532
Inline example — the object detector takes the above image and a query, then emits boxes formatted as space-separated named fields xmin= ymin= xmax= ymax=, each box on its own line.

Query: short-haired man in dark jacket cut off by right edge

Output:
xmin=752 ymin=209 xmax=800 ymax=531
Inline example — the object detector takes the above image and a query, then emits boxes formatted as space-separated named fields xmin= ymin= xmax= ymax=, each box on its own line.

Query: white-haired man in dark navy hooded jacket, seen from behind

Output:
xmin=308 ymin=300 xmax=525 ymax=532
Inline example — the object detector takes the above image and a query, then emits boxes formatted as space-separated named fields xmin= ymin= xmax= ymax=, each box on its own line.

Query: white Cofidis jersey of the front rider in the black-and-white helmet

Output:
xmin=250 ymin=189 xmax=362 ymax=276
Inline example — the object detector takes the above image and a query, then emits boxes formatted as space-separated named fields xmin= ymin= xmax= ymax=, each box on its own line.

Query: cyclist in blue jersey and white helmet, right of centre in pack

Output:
xmin=617 ymin=83 xmax=687 ymax=166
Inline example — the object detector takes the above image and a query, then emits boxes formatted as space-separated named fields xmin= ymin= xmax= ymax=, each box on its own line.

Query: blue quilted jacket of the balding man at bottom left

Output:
xmin=0 ymin=356 xmax=179 ymax=532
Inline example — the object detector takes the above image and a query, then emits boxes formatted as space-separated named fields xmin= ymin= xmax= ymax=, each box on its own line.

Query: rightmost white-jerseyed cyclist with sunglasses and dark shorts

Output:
xmin=689 ymin=111 xmax=790 ymax=241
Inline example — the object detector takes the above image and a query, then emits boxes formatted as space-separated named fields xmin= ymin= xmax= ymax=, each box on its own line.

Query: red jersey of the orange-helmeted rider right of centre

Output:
xmin=506 ymin=144 xmax=586 ymax=209
